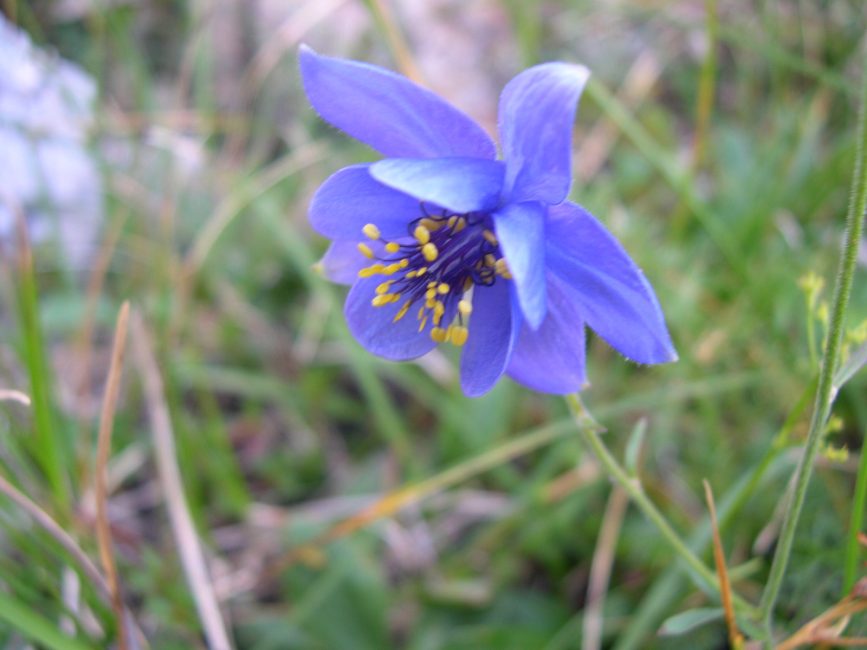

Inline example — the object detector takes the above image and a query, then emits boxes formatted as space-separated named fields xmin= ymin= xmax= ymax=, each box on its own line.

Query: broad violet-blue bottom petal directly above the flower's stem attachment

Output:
xmin=506 ymin=275 xmax=586 ymax=395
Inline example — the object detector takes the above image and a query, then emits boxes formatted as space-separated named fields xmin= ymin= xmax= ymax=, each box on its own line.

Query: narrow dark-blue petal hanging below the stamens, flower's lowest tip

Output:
xmin=461 ymin=280 xmax=521 ymax=397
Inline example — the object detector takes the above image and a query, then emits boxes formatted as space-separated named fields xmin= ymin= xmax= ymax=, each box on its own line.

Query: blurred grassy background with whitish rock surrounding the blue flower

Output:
xmin=0 ymin=0 xmax=867 ymax=650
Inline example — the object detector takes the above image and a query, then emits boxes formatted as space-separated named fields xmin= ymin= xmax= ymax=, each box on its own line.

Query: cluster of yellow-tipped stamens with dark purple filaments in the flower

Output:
xmin=358 ymin=208 xmax=512 ymax=346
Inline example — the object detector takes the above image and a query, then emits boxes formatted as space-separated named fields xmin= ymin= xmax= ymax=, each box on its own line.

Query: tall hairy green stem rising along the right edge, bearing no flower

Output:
xmin=759 ymin=50 xmax=867 ymax=639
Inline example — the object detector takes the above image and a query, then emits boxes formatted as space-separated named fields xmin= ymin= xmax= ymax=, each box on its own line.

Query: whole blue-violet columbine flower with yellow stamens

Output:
xmin=300 ymin=46 xmax=677 ymax=396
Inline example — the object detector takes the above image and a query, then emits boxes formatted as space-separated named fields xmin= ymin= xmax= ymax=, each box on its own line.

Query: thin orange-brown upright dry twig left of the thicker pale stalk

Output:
xmin=94 ymin=301 xmax=129 ymax=650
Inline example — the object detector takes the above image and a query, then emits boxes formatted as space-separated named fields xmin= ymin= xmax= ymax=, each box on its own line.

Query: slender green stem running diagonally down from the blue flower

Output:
xmin=566 ymin=394 xmax=755 ymax=614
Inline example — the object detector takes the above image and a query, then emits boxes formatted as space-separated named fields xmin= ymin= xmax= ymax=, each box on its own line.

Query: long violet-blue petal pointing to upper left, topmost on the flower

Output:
xmin=298 ymin=45 xmax=496 ymax=159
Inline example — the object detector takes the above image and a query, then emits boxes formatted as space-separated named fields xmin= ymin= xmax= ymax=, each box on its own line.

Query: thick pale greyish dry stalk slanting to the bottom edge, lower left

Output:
xmin=131 ymin=311 xmax=232 ymax=650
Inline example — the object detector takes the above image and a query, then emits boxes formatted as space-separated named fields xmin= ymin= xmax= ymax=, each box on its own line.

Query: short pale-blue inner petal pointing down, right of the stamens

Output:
xmin=493 ymin=203 xmax=546 ymax=329
